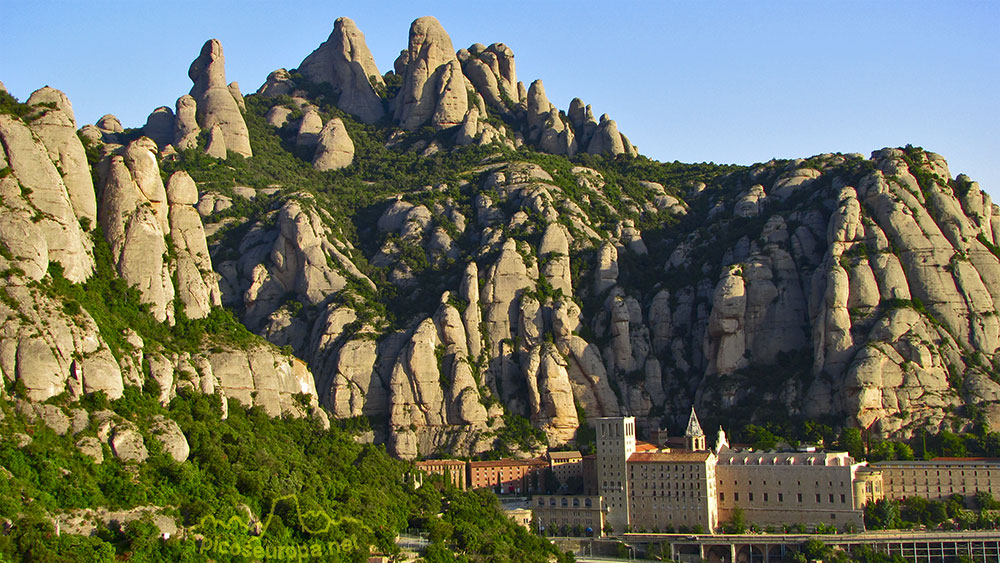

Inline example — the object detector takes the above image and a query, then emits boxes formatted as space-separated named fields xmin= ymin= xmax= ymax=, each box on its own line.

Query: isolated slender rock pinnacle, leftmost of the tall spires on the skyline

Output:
xmin=188 ymin=39 xmax=253 ymax=156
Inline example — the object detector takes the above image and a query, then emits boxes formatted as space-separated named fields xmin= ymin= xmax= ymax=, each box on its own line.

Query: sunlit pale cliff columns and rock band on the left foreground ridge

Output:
xmin=0 ymin=87 xmax=325 ymax=428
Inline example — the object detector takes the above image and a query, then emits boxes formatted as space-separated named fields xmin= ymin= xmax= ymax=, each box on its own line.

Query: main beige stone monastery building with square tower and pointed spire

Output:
xmin=560 ymin=409 xmax=882 ymax=533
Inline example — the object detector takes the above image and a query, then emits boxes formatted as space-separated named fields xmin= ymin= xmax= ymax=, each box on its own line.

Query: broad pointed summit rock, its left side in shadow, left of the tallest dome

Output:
xmin=299 ymin=18 xmax=385 ymax=123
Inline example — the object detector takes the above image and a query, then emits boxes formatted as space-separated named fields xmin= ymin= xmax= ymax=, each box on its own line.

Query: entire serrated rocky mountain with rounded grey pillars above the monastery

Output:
xmin=0 ymin=17 xmax=1000 ymax=458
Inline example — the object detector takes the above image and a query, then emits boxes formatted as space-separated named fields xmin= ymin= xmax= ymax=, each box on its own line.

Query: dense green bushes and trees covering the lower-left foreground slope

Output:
xmin=0 ymin=387 xmax=576 ymax=561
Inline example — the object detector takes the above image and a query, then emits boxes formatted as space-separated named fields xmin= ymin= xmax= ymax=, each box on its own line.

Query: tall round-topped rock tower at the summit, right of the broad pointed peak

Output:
xmin=393 ymin=16 xmax=468 ymax=131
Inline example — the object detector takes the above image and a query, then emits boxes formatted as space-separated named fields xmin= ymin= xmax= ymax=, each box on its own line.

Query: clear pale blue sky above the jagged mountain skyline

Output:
xmin=0 ymin=0 xmax=1000 ymax=196
